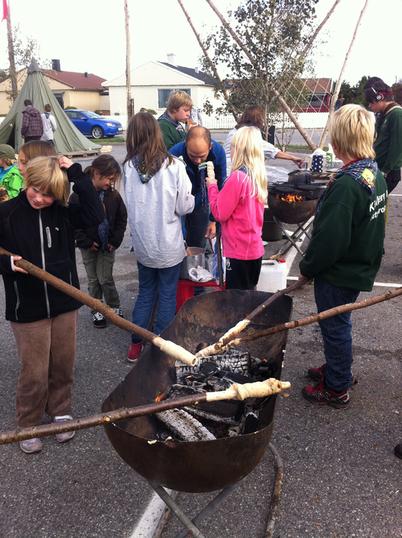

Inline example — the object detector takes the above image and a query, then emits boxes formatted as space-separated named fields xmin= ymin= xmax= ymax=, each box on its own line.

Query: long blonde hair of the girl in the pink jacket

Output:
xmin=231 ymin=127 xmax=268 ymax=202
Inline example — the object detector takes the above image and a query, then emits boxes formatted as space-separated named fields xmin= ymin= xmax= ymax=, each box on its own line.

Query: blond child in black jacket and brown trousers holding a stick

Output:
xmin=0 ymin=141 xmax=103 ymax=454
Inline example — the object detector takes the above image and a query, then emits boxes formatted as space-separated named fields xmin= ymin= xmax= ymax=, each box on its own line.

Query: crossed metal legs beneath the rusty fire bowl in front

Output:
xmin=151 ymin=482 xmax=239 ymax=538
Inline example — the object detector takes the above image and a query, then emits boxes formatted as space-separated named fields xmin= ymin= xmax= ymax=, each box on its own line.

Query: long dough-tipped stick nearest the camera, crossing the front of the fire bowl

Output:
xmin=0 ymin=378 xmax=291 ymax=445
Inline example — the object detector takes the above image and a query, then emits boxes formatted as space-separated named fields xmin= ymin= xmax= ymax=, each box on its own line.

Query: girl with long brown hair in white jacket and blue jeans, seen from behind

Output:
xmin=124 ymin=112 xmax=194 ymax=362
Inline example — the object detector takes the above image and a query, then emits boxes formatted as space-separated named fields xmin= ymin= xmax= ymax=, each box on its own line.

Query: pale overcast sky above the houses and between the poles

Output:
xmin=0 ymin=0 xmax=402 ymax=83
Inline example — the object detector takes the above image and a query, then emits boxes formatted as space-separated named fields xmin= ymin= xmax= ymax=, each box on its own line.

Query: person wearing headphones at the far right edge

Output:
xmin=364 ymin=77 xmax=402 ymax=193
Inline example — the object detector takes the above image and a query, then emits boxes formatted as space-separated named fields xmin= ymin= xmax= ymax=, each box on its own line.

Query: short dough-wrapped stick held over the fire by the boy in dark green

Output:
xmin=196 ymin=280 xmax=306 ymax=358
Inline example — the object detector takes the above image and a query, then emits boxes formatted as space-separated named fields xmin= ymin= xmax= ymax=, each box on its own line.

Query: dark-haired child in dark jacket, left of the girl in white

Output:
xmin=71 ymin=155 xmax=127 ymax=329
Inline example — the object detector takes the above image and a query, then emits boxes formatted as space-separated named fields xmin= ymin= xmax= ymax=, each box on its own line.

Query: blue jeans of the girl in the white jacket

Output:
xmin=131 ymin=262 xmax=181 ymax=343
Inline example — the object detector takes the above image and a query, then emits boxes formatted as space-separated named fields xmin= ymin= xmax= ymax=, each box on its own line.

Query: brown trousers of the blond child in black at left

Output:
xmin=11 ymin=310 xmax=77 ymax=428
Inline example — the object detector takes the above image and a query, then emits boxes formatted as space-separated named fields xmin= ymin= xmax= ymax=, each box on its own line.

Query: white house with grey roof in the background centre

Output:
xmin=102 ymin=55 xmax=225 ymax=127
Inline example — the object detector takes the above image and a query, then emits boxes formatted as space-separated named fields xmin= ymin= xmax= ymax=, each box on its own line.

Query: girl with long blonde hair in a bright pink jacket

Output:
xmin=207 ymin=127 xmax=268 ymax=290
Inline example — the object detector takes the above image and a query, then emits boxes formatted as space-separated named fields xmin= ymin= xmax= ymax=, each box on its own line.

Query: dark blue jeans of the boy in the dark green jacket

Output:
xmin=314 ymin=278 xmax=360 ymax=391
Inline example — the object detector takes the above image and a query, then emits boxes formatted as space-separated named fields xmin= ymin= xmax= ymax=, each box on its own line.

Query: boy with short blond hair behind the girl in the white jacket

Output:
xmin=158 ymin=91 xmax=193 ymax=149
